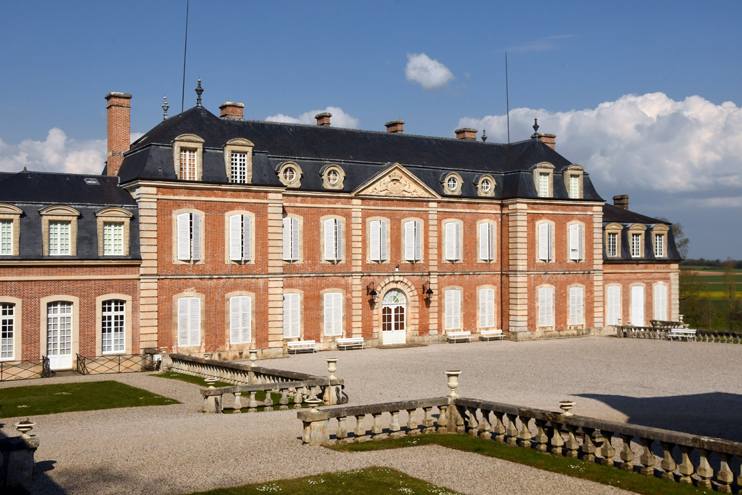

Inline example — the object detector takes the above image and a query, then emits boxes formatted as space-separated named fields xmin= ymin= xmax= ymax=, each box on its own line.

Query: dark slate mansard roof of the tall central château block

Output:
xmin=118 ymin=106 xmax=603 ymax=201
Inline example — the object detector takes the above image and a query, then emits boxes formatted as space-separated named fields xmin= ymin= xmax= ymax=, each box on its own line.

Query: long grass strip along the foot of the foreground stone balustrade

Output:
xmin=330 ymin=435 xmax=715 ymax=495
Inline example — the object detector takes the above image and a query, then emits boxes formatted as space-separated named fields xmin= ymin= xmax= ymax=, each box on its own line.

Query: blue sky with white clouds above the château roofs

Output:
xmin=0 ymin=0 xmax=742 ymax=259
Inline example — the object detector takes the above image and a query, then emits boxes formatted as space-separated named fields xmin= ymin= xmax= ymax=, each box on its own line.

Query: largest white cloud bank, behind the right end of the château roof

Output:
xmin=457 ymin=93 xmax=742 ymax=196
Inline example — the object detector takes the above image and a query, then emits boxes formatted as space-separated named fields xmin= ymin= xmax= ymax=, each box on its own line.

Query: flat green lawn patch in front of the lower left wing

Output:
xmin=0 ymin=381 xmax=180 ymax=418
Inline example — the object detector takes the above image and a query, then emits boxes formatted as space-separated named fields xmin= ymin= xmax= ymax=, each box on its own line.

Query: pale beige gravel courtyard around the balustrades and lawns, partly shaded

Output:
xmin=0 ymin=337 xmax=742 ymax=494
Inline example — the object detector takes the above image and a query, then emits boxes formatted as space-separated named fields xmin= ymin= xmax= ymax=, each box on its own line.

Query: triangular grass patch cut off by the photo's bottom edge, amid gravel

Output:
xmin=193 ymin=467 xmax=458 ymax=495
